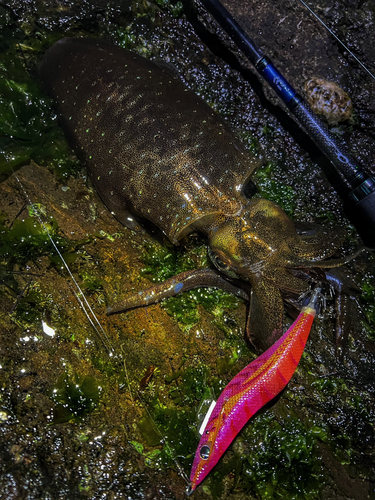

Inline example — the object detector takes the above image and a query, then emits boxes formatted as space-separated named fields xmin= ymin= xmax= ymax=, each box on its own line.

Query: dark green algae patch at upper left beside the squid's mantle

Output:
xmin=0 ymin=7 xmax=82 ymax=180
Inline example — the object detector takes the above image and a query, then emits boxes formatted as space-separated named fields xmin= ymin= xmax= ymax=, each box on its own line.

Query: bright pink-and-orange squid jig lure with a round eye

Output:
xmin=187 ymin=288 xmax=321 ymax=495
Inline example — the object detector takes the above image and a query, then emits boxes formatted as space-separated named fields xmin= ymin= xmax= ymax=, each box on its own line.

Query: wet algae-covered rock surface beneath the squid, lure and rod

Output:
xmin=0 ymin=0 xmax=375 ymax=500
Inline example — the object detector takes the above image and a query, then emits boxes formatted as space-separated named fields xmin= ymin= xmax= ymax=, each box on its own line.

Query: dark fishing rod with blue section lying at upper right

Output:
xmin=201 ymin=0 xmax=375 ymax=247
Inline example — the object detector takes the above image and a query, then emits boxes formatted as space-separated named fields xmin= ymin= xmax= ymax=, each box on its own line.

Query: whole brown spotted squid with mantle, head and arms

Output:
xmin=39 ymin=38 xmax=352 ymax=351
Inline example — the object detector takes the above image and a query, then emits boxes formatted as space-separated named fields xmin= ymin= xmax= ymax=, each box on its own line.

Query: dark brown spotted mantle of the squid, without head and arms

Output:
xmin=39 ymin=38 xmax=259 ymax=243
